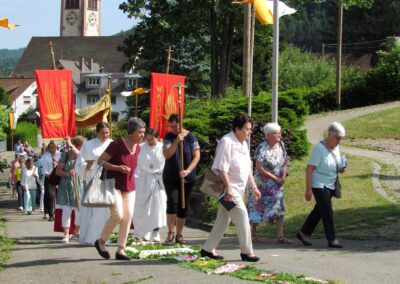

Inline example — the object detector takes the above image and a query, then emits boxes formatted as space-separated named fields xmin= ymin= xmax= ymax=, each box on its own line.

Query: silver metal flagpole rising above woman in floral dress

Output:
xmin=271 ymin=0 xmax=279 ymax=122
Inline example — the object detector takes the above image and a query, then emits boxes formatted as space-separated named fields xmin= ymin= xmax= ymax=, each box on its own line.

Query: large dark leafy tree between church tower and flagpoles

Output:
xmin=120 ymin=0 xmax=270 ymax=96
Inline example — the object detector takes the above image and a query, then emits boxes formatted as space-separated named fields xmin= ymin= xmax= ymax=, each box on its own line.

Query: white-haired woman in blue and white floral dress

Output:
xmin=247 ymin=123 xmax=291 ymax=244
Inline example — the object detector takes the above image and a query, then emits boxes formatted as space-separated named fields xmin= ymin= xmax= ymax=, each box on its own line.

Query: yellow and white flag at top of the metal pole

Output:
xmin=233 ymin=0 xmax=296 ymax=25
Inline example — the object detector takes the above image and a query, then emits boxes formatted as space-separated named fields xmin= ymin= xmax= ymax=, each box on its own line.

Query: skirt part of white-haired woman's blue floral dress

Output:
xmin=247 ymin=185 xmax=285 ymax=224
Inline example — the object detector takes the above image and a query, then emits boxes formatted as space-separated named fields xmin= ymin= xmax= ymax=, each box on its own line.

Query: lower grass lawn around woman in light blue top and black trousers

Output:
xmin=253 ymin=156 xmax=400 ymax=240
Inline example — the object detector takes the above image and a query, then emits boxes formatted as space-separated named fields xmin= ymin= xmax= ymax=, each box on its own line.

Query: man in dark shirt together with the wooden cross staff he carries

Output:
xmin=163 ymin=81 xmax=200 ymax=244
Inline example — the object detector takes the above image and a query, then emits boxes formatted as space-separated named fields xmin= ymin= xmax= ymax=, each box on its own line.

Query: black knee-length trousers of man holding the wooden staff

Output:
xmin=163 ymin=179 xmax=194 ymax=218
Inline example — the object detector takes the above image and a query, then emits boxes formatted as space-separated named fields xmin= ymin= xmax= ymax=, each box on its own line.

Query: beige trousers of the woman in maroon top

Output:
xmin=100 ymin=189 xmax=135 ymax=247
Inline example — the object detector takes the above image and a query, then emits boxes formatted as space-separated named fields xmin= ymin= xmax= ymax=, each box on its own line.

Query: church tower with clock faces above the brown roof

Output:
xmin=60 ymin=0 xmax=100 ymax=37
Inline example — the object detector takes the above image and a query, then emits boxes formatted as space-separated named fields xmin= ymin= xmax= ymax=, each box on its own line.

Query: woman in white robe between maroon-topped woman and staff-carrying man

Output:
xmin=133 ymin=128 xmax=167 ymax=242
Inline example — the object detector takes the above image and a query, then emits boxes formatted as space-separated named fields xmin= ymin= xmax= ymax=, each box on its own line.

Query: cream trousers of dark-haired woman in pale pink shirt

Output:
xmin=202 ymin=199 xmax=253 ymax=254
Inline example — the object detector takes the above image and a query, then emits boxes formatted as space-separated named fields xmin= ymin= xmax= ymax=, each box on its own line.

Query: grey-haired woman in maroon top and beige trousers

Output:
xmin=95 ymin=117 xmax=146 ymax=260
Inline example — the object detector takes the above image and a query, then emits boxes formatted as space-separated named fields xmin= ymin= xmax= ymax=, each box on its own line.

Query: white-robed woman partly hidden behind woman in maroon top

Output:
xmin=75 ymin=122 xmax=112 ymax=245
